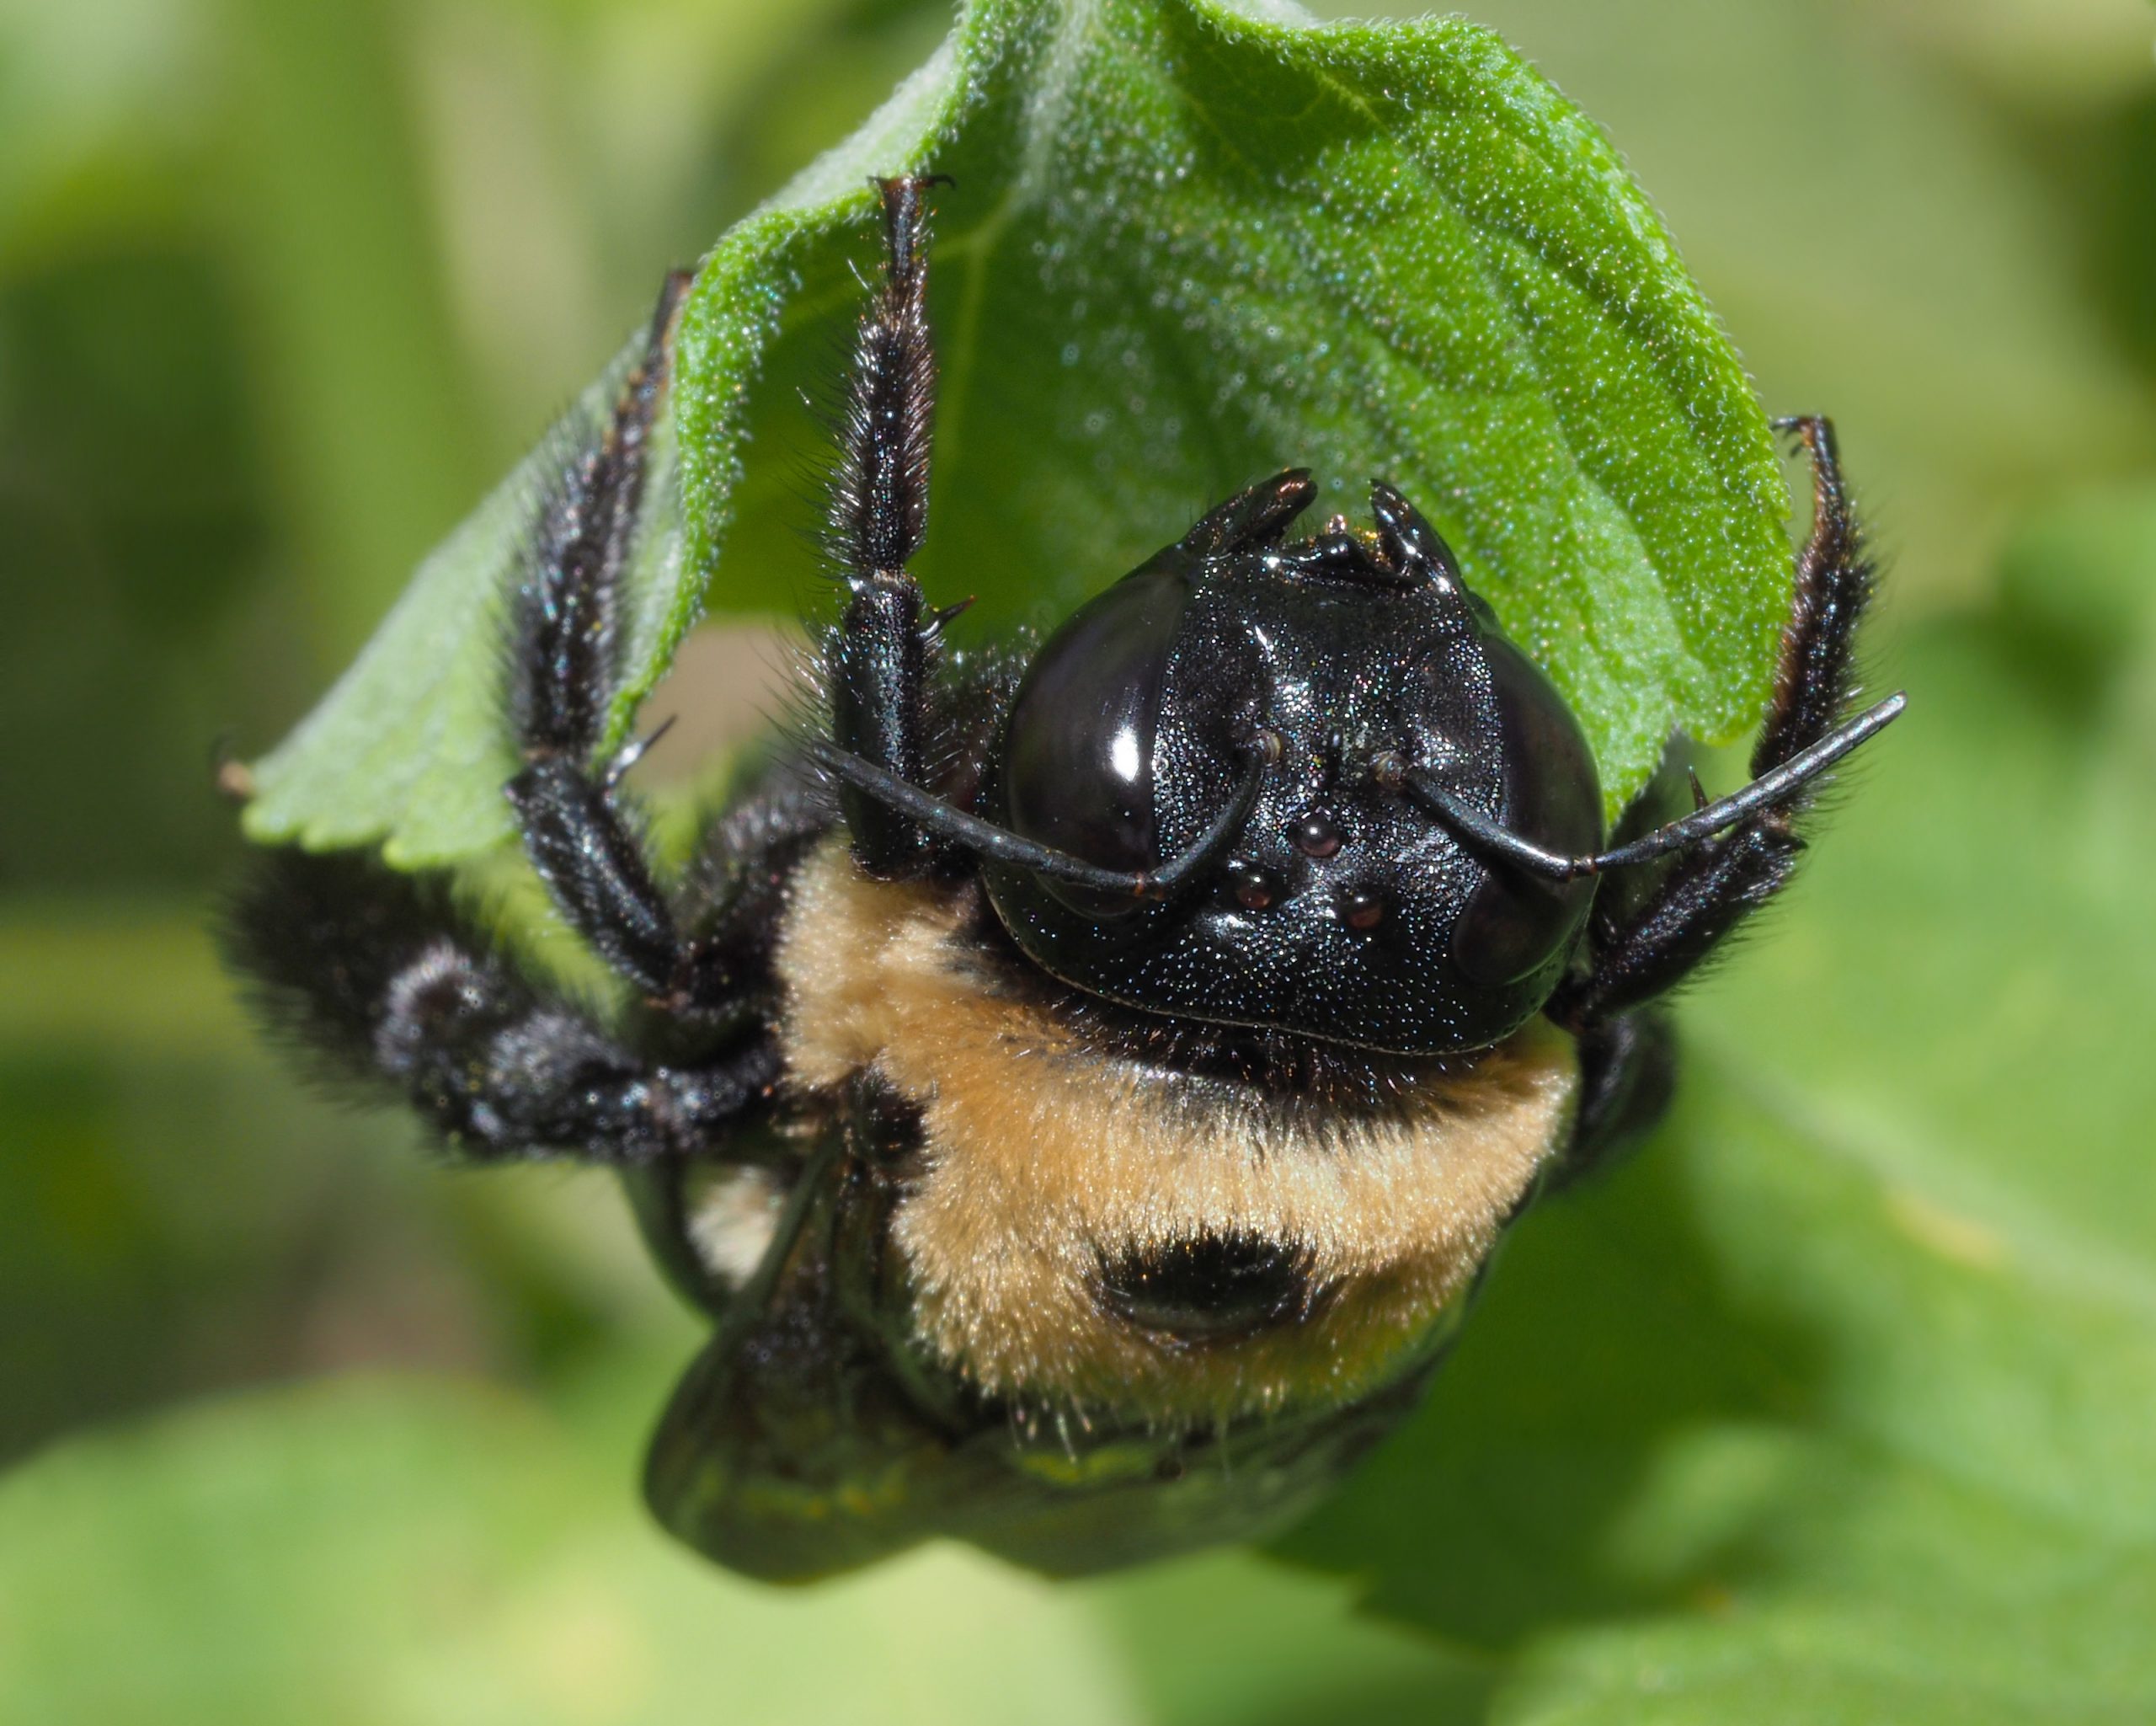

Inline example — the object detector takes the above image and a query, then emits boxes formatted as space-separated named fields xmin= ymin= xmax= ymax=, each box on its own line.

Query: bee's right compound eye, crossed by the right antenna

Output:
xmin=1453 ymin=630 xmax=1602 ymax=988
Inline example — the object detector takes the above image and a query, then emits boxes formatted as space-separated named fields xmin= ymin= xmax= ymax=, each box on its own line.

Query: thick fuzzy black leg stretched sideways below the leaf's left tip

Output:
xmin=224 ymin=850 xmax=781 ymax=1163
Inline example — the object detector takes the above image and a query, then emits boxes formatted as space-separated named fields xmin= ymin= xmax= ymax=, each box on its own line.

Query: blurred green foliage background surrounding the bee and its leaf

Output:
xmin=0 ymin=0 xmax=2156 ymax=1722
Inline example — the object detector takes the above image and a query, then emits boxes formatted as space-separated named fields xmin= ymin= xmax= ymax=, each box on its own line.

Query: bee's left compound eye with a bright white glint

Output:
xmin=1002 ymin=565 xmax=1190 ymax=917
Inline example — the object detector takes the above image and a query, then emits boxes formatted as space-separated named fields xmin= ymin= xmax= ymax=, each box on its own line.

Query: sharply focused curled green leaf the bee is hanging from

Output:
xmin=248 ymin=0 xmax=1790 ymax=865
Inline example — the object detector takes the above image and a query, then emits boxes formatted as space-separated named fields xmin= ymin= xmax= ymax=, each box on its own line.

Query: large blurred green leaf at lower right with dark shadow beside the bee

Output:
xmin=1291 ymin=526 xmax=2156 ymax=1722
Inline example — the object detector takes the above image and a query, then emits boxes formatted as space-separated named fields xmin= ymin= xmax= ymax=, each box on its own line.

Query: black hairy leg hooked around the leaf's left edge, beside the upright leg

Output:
xmin=504 ymin=272 xmax=798 ymax=1023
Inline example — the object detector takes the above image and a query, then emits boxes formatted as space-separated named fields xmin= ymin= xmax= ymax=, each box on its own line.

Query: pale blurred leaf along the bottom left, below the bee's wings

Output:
xmin=0 ymin=1370 xmax=1465 ymax=1726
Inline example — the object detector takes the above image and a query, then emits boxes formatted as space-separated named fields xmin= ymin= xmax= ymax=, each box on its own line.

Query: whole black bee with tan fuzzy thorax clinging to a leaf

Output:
xmin=228 ymin=177 xmax=1902 ymax=1579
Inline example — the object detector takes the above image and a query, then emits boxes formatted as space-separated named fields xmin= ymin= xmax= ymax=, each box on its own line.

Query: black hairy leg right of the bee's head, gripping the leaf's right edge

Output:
xmin=1548 ymin=419 xmax=1876 ymax=1031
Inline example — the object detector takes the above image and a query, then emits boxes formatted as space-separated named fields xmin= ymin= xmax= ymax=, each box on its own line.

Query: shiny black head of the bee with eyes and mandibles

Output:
xmin=985 ymin=473 xmax=1602 ymax=1053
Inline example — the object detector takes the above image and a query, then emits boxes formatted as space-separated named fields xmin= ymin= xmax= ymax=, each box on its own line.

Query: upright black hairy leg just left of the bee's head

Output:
xmin=824 ymin=177 xmax=948 ymax=878
